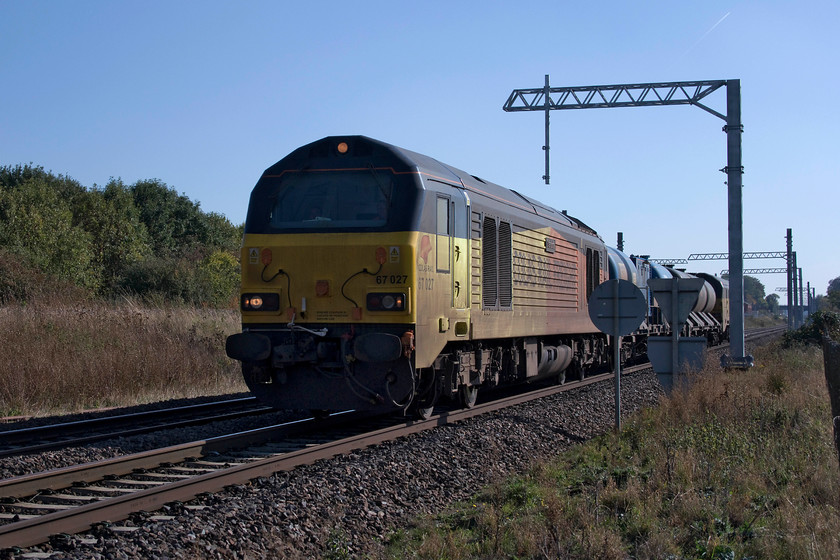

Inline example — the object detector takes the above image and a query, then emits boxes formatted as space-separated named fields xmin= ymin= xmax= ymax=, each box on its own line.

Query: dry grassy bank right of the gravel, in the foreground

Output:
xmin=390 ymin=346 xmax=840 ymax=560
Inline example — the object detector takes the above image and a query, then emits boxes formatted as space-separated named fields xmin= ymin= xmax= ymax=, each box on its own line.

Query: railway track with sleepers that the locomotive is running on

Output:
xmin=0 ymin=328 xmax=784 ymax=549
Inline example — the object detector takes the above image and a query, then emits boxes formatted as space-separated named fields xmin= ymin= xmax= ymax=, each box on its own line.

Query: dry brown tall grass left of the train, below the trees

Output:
xmin=0 ymin=298 xmax=246 ymax=416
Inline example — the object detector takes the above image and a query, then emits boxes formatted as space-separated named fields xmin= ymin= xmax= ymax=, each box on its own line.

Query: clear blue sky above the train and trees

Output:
xmin=0 ymin=0 xmax=840 ymax=302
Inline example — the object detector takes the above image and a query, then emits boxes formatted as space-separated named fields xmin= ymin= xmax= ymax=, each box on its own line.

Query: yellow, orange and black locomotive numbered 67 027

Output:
xmin=226 ymin=136 xmax=728 ymax=417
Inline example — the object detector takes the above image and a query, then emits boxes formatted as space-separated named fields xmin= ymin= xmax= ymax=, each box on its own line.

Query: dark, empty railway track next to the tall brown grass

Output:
xmin=0 ymin=397 xmax=273 ymax=458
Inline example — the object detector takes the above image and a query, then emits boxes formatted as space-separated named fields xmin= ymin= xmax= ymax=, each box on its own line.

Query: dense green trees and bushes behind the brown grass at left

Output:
xmin=0 ymin=165 xmax=243 ymax=306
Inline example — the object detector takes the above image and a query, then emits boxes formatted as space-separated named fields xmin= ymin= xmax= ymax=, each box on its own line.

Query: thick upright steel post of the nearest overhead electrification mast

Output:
xmin=724 ymin=80 xmax=751 ymax=365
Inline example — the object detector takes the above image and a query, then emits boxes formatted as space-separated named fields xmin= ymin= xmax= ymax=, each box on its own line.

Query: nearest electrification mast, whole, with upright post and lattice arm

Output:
xmin=503 ymin=74 xmax=753 ymax=369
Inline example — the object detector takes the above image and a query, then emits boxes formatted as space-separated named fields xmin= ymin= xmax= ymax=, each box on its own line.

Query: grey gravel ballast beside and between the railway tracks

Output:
xmin=0 ymin=370 xmax=662 ymax=559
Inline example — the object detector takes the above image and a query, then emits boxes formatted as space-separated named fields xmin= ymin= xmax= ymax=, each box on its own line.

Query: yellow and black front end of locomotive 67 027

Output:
xmin=227 ymin=138 xmax=422 ymax=410
